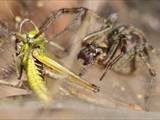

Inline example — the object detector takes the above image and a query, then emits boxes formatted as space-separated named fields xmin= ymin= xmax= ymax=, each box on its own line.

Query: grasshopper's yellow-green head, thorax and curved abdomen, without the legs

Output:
xmin=16 ymin=31 xmax=51 ymax=102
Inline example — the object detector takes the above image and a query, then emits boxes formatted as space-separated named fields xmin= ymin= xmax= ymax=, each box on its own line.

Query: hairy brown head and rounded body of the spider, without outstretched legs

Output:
xmin=78 ymin=25 xmax=151 ymax=71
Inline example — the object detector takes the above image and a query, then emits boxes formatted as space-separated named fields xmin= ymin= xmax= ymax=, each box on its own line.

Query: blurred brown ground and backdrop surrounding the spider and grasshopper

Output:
xmin=0 ymin=0 xmax=160 ymax=119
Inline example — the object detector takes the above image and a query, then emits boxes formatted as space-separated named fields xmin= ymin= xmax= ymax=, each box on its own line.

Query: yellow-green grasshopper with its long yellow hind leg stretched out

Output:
xmin=15 ymin=20 xmax=99 ymax=102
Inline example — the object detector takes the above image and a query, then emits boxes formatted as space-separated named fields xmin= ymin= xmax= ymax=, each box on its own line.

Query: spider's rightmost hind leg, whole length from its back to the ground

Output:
xmin=130 ymin=26 xmax=156 ymax=111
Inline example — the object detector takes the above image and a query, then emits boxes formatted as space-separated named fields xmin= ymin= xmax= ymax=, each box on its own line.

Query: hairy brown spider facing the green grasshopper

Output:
xmin=77 ymin=9 xmax=156 ymax=110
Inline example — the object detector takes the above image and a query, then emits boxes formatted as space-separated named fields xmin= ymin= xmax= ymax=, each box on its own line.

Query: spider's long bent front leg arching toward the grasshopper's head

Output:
xmin=39 ymin=7 xmax=88 ymax=55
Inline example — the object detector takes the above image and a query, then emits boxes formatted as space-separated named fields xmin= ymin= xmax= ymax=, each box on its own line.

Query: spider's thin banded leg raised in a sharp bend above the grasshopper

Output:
xmin=34 ymin=7 xmax=88 ymax=57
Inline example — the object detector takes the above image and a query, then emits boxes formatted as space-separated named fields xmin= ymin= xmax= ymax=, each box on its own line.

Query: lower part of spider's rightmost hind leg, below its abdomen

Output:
xmin=139 ymin=48 xmax=156 ymax=111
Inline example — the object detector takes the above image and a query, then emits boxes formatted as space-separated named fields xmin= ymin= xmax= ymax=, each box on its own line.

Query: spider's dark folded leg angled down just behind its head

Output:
xmin=100 ymin=25 xmax=132 ymax=80
